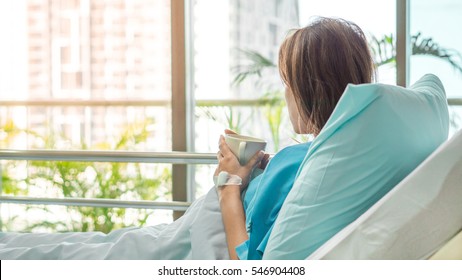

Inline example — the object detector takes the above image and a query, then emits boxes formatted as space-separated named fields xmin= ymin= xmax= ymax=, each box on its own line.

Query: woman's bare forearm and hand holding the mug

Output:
xmin=215 ymin=136 xmax=264 ymax=260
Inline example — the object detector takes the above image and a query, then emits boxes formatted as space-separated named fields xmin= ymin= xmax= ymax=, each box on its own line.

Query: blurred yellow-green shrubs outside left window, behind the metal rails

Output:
xmin=2 ymin=120 xmax=171 ymax=232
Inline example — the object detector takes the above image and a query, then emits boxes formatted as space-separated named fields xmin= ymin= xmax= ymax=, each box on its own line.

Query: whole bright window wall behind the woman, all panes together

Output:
xmin=0 ymin=0 xmax=462 ymax=234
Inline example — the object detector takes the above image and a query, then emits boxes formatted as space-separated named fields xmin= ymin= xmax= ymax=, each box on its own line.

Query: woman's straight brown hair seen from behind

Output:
xmin=279 ymin=18 xmax=375 ymax=135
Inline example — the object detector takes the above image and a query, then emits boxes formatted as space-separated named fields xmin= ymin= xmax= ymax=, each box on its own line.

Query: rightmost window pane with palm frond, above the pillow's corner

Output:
xmin=410 ymin=0 xmax=462 ymax=135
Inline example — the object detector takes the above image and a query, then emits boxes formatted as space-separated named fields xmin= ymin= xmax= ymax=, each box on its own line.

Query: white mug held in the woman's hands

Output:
xmin=225 ymin=134 xmax=266 ymax=165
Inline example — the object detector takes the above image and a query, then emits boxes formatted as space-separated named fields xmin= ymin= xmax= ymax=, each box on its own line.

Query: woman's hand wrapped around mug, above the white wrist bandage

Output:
xmin=214 ymin=135 xmax=265 ymax=191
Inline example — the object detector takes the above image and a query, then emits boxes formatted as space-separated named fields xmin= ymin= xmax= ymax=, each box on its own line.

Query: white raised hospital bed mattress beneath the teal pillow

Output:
xmin=309 ymin=131 xmax=462 ymax=259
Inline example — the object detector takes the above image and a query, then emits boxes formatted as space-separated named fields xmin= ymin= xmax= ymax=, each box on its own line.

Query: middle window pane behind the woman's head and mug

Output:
xmin=189 ymin=0 xmax=396 ymax=195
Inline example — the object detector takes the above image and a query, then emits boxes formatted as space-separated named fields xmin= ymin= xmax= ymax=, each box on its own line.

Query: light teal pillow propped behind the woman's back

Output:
xmin=263 ymin=74 xmax=449 ymax=259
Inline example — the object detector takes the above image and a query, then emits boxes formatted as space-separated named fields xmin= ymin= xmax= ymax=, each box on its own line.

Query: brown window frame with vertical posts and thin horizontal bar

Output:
xmin=0 ymin=0 xmax=462 ymax=223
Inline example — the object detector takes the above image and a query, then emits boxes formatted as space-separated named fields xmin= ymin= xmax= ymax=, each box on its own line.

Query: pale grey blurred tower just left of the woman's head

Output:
xmin=229 ymin=0 xmax=299 ymax=99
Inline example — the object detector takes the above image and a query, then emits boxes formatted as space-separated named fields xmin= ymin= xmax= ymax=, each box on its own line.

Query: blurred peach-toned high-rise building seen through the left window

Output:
xmin=20 ymin=0 xmax=171 ymax=150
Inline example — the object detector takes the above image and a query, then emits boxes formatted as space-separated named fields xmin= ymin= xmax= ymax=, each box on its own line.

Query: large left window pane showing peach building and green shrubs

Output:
xmin=0 ymin=0 xmax=172 ymax=231
